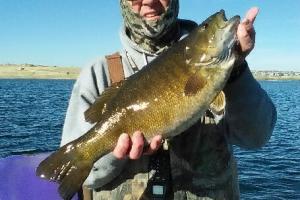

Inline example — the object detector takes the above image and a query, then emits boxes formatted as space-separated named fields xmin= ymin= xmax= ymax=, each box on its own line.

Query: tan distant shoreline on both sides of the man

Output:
xmin=0 ymin=64 xmax=300 ymax=81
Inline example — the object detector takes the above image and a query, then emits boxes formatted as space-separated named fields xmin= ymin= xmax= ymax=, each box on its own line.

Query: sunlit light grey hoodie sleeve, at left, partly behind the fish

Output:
xmin=61 ymin=61 xmax=126 ymax=188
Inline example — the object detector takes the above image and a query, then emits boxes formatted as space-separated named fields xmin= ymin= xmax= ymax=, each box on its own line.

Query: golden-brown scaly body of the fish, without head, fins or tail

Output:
xmin=78 ymin=49 xmax=230 ymax=160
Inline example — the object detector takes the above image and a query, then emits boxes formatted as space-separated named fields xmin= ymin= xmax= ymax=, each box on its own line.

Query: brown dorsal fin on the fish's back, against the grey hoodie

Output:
xmin=84 ymin=81 xmax=124 ymax=123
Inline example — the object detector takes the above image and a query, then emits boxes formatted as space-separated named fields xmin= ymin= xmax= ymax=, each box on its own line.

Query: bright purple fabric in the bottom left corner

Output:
xmin=0 ymin=153 xmax=78 ymax=200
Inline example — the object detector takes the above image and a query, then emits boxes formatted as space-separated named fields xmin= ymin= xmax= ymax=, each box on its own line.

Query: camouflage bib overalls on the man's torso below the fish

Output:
xmin=93 ymin=108 xmax=239 ymax=200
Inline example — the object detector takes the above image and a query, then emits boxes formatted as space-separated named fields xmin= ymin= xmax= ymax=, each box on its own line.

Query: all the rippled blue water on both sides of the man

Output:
xmin=0 ymin=79 xmax=300 ymax=200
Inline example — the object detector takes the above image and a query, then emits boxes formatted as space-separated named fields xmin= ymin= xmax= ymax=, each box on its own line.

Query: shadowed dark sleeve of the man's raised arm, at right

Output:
xmin=224 ymin=63 xmax=277 ymax=148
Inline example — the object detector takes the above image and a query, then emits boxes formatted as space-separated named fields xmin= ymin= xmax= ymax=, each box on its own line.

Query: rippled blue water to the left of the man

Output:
xmin=0 ymin=79 xmax=74 ymax=157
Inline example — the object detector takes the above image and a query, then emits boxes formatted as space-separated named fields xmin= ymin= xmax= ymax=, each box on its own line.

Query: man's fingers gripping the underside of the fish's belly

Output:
xmin=113 ymin=131 xmax=162 ymax=160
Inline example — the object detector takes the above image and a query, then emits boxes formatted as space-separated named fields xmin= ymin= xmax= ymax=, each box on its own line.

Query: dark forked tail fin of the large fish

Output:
xmin=36 ymin=143 xmax=93 ymax=199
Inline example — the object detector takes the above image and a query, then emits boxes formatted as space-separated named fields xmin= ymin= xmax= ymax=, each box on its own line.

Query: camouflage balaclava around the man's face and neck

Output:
xmin=120 ymin=0 xmax=179 ymax=53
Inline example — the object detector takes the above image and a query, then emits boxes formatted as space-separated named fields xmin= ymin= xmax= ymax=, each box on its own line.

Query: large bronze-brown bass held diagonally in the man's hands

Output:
xmin=36 ymin=10 xmax=240 ymax=199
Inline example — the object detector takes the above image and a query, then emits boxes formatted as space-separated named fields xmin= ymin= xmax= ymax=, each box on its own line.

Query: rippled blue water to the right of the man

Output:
xmin=235 ymin=81 xmax=300 ymax=200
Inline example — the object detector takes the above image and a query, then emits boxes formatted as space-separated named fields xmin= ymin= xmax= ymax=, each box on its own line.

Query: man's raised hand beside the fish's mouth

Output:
xmin=237 ymin=7 xmax=259 ymax=59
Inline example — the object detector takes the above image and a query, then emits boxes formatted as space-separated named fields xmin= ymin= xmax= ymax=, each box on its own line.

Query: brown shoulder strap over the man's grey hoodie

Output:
xmin=105 ymin=52 xmax=125 ymax=85
